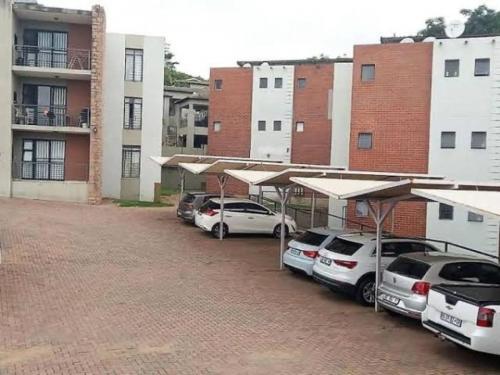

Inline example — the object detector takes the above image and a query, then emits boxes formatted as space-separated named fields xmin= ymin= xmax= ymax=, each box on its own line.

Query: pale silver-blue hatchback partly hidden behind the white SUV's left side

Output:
xmin=283 ymin=227 xmax=345 ymax=276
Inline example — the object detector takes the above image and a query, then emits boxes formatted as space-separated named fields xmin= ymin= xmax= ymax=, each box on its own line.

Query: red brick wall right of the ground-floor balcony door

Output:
xmin=64 ymin=134 xmax=89 ymax=181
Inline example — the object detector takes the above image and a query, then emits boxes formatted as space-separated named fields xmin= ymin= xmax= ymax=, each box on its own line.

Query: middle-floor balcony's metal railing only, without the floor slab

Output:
xmin=12 ymin=104 xmax=90 ymax=128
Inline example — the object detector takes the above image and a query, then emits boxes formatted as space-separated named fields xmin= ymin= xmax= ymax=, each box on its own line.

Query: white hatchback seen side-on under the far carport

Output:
xmin=195 ymin=198 xmax=297 ymax=238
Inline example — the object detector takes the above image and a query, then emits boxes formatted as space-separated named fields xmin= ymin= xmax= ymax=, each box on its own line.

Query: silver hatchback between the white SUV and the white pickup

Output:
xmin=377 ymin=252 xmax=500 ymax=320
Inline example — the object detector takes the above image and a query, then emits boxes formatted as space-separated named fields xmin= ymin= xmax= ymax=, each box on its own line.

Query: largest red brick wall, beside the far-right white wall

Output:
xmin=348 ymin=43 xmax=432 ymax=236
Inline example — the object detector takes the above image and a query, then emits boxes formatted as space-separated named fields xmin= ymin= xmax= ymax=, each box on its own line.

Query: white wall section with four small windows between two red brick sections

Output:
xmin=250 ymin=65 xmax=294 ymax=163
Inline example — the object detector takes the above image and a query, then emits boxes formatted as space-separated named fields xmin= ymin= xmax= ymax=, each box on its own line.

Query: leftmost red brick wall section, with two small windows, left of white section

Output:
xmin=207 ymin=68 xmax=252 ymax=195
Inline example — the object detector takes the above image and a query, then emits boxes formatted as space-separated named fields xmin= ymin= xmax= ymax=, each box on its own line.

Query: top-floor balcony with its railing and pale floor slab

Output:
xmin=12 ymin=45 xmax=91 ymax=80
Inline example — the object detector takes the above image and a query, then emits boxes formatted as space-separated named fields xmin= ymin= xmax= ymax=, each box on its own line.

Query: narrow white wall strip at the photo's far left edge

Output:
xmin=0 ymin=0 xmax=13 ymax=197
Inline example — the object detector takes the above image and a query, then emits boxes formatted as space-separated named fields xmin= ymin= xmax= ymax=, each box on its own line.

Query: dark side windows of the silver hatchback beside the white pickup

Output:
xmin=439 ymin=262 xmax=500 ymax=285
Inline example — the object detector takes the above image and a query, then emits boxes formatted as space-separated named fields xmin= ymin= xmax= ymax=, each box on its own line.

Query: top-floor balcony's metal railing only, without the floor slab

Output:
xmin=14 ymin=45 xmax=90 ymax=70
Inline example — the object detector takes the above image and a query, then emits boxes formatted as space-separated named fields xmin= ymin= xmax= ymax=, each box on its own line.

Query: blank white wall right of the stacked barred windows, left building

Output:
xmin=140 ymin=37 xmax=165 ymax=201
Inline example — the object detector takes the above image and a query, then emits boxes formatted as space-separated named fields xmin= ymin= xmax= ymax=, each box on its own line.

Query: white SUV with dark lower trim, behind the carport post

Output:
xmin=313 ymin=233 xmax=437 ymax=305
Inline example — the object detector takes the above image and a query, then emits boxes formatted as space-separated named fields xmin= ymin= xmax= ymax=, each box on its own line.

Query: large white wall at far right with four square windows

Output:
xmin=427 ymin=38 xmax=500 ymax=254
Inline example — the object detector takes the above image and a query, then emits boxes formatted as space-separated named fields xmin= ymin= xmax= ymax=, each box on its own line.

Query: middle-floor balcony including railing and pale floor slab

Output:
xmin=12 ymin=104 xmax=90 ymax=133
